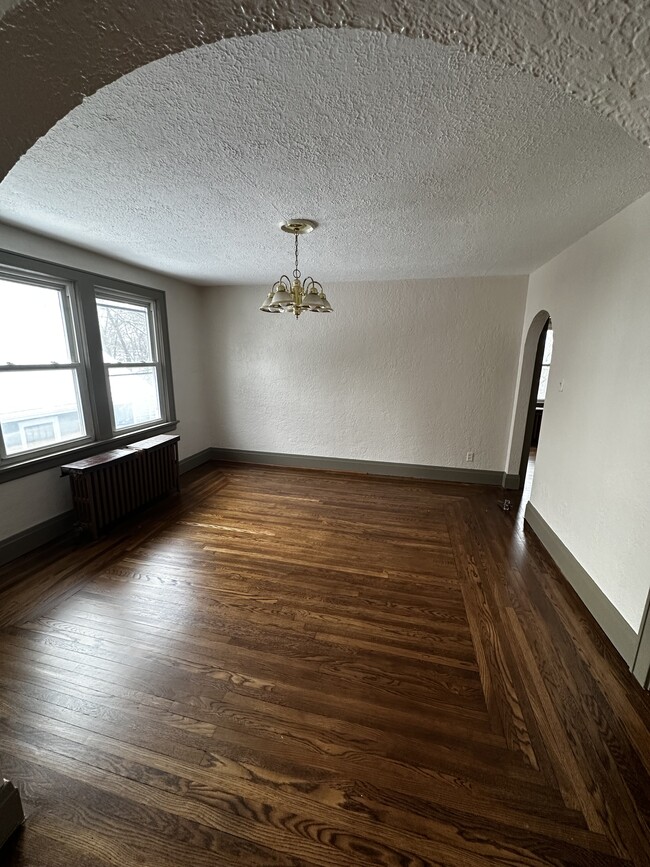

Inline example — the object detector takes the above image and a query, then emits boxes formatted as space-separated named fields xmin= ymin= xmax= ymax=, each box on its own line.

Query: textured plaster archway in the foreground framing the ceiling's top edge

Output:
xmin=0 ymin=0 xmax=650 ymax=185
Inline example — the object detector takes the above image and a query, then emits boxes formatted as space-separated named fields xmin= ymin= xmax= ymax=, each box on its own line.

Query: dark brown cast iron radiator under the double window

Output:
xmin=61 ymin=435 xmax=180 ymax=539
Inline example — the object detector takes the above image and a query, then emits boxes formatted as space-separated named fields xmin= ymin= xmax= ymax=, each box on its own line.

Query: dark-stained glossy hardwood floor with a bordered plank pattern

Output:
xmin=0 ymin=465 xmax=650 ymax=867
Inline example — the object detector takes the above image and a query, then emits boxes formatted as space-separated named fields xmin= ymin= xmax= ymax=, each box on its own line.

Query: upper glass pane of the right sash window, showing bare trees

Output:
xmin=97 ymin=298 xmax=156 ymax=364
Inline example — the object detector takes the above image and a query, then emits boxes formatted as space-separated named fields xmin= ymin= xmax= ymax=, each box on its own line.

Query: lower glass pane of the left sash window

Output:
xmin=0 ymin=370 xmax=86 ymax=455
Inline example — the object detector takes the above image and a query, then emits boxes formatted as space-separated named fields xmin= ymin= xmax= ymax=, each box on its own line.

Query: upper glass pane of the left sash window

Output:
xmin=0 ymin=278 xmax=74 ymax=365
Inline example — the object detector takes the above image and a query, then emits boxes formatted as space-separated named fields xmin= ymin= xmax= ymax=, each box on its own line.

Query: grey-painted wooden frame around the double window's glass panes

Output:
xmin=0 ymin=249 xmax=178 ymax=484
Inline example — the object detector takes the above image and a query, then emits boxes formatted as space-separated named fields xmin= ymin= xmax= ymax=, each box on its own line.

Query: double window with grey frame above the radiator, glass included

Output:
xmin=0 ymin=253 xmax=176 ymax=481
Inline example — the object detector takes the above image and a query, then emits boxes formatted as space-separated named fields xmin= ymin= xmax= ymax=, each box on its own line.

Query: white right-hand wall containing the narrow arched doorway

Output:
xmin=524 ymin=194 xmax=650 ymax=630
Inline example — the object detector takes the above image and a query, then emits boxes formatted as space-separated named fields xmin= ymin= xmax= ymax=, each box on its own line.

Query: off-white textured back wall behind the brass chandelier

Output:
xmin=206 ymin=277 xmax=527 ymax=470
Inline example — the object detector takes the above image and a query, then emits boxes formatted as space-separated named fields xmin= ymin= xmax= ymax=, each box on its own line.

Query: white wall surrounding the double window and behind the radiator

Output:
xmin=0 ymin=224 xmax=211 ymax=539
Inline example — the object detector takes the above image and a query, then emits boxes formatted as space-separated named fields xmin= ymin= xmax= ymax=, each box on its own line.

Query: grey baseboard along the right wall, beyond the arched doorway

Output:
xmin=524 ymin=502 xmax=638 ymax=666
